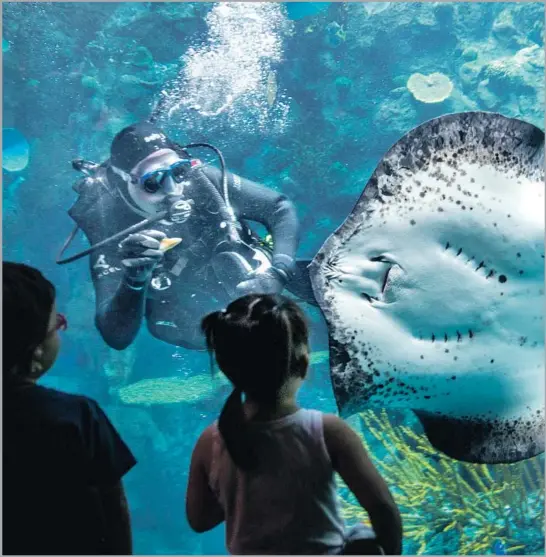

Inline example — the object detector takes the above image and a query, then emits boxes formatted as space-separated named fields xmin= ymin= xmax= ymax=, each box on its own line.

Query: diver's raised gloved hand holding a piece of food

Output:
xmin=119 ymin=230 xmax=166 ymax=289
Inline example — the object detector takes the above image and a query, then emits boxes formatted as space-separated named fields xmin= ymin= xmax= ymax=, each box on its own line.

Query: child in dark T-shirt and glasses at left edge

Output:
xmin=2 ymin=262 xmax=136 ymax=555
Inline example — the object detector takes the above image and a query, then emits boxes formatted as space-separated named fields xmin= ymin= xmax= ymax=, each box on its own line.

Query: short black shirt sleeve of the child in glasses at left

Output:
xmin=84 ymin=399 xmax=136 ymax=486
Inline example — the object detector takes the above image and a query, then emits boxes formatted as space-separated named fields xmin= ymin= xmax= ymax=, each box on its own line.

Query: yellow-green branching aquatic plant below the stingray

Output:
xmin=340 ymin=410 xmax=544 ymax=555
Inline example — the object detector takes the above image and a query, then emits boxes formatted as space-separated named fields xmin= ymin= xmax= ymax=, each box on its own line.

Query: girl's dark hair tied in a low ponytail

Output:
xmin=201 ymin=294 xmax=309 ymax=470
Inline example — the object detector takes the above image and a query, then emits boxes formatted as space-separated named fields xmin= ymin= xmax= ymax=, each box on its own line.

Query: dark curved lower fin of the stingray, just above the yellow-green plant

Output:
xmin=415 ymin=411 xmax=544 ymax=464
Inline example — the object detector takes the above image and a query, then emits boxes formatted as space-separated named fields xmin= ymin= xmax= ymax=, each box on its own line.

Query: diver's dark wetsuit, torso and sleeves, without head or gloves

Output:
xmin=91 ymin=166 xmax=299 ymax=350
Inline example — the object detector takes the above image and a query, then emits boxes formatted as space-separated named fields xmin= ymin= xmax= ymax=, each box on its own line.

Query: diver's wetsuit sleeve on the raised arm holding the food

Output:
xmin=90 ymin=242 xmax=147 ymax=350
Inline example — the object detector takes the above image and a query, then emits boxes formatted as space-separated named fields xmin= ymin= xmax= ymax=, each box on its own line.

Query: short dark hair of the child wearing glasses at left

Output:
xmin=2 ymin=261 xmax=55 ymax=379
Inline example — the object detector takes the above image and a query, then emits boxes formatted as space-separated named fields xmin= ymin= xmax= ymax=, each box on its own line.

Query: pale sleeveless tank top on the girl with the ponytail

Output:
xmin=209 ymin=409 xmax=345 ymax=555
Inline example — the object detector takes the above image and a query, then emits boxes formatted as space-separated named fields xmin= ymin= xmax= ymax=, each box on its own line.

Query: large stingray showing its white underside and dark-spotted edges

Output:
xmin=309 ymin=112 xmax=544 ymax=463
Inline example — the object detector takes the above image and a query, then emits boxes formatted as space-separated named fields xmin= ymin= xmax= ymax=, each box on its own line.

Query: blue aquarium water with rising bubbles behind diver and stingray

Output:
xmin=2 ymin=2 xmax=544 ymax=555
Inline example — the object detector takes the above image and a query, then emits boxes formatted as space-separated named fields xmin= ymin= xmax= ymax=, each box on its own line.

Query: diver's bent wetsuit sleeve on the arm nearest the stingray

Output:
xmin=202 ymin=167 xmax=299 ymax=272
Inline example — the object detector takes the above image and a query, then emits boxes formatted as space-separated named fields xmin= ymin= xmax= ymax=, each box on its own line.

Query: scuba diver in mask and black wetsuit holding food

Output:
xmin=57 ymin=121 xmax=314 ymax=350
